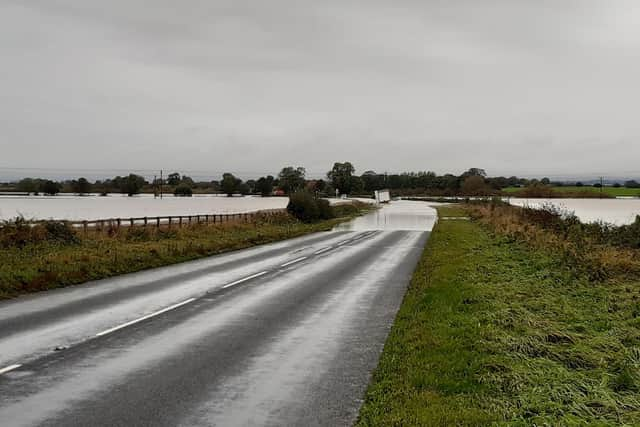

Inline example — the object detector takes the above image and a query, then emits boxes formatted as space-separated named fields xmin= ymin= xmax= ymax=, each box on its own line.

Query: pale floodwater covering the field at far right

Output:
xmin=509 ymin=198 xmax=640 ymax=225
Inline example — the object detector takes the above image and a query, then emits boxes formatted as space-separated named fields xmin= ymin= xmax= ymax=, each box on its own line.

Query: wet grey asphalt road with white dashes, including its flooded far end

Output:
xmin=0 ymin=202 xmax=435 ymax=426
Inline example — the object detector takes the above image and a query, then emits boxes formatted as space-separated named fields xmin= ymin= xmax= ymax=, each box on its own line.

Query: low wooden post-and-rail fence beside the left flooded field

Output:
xmin=7 ymin=209 xmax=287 ymax=233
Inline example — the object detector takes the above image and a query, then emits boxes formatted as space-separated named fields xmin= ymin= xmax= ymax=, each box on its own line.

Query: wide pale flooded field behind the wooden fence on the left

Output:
xmin=0 ymin=194 xmax=289 ymax=221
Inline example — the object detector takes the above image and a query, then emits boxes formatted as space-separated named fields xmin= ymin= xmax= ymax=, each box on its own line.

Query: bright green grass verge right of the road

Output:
xmin=359 ymin=208 xmax=640 ymax=426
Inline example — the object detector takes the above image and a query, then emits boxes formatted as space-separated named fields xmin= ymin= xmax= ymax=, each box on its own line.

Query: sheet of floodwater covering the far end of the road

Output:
xmin=334 ymin=200 xmax=438 ymax=231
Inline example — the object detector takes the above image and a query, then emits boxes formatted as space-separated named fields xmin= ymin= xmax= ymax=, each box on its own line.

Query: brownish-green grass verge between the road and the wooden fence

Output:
xmin=0 ymin=209 xmax=366 ymax=299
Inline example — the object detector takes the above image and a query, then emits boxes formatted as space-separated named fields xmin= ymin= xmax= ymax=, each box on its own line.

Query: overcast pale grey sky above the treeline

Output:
xmin=0 ymin=0 xmax=640 ymax=181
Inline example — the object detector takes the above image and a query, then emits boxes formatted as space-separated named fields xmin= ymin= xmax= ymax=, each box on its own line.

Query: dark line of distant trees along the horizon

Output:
xmin=0 ymin=162 xmax=640 ymax=196
